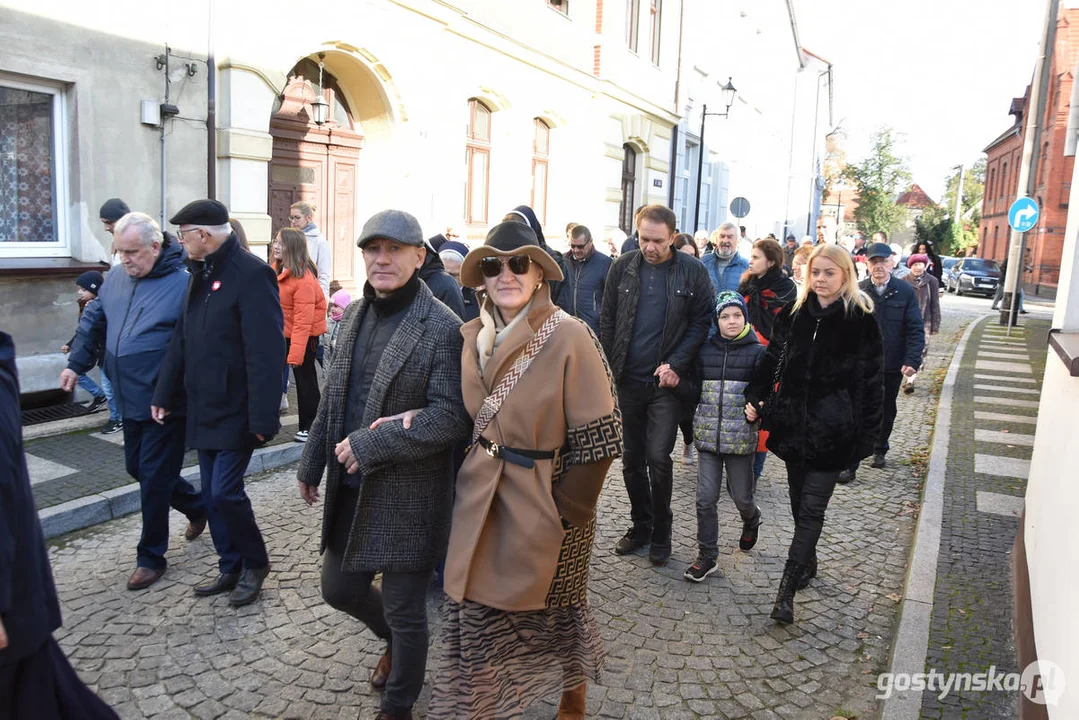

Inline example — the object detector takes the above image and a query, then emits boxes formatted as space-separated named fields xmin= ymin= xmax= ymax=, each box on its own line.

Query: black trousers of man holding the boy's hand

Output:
xmin=618 ymin=383 xmax=682 ymax=545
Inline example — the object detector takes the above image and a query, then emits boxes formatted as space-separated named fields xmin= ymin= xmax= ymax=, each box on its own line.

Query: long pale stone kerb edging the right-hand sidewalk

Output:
xmin=880 ymin=315 xmax=992 ymax=720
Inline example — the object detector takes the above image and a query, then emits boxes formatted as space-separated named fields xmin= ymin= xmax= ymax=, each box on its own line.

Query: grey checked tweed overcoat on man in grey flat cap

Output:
xmin=297 ymin=283 xmax=472 ymax=572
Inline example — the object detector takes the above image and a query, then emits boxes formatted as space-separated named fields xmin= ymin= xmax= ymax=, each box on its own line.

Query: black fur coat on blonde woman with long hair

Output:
xmin=746 ymin=293 xmax=884 ymax=471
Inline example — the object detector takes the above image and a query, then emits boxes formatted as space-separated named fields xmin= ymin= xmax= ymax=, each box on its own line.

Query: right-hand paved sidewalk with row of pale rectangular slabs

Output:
xmin=921 ymin=317 xmax=1050 ymax=720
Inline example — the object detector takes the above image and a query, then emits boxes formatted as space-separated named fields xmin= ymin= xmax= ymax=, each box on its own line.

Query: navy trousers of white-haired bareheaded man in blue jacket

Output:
xmin=124 ymin=418 xmax=206 ymax=570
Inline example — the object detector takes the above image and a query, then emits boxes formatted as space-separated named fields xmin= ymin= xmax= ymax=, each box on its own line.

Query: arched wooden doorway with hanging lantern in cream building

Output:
xmin=269 ymin=58 xmax=364 ymax=288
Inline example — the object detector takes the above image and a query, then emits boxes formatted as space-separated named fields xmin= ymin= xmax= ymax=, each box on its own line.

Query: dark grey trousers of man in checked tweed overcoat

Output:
xmin=323 ymin=485 xmax=432 ymax=716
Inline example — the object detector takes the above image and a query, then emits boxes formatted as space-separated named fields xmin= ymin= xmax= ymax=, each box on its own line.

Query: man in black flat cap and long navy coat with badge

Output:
xmin=152 ymin=200 xmax=285 ymax=607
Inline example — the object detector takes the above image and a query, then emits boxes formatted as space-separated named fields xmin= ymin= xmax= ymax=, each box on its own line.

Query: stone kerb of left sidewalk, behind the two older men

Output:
xmin=38 ymin=443 xmax=303 ymax=540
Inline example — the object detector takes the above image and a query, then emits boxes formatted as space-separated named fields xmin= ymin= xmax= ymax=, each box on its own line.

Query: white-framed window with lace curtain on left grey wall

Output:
xmin=0 ymin=76 xmax=70 ymax=257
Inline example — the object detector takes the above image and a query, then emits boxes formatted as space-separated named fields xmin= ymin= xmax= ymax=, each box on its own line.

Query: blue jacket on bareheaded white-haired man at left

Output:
xmin=68 ymin=241 xmax=188 ymax=420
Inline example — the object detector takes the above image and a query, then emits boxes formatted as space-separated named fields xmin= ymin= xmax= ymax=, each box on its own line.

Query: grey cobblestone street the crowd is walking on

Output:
xmin=51 ymin=303 xmax=981 ymax=720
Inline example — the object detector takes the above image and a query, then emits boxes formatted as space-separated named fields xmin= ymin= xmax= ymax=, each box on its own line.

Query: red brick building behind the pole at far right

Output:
xmin=978 ymin=9 xmax=1079 ymax=297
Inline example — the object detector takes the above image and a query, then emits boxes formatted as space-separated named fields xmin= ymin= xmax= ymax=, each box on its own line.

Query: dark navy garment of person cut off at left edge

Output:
xmin=0 ymin=332 xmax=60 ymax=666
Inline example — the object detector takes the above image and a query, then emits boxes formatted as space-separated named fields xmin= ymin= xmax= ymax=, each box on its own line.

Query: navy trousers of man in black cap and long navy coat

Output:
xmin=199 ymin=449 xmax=270 ymax=573
